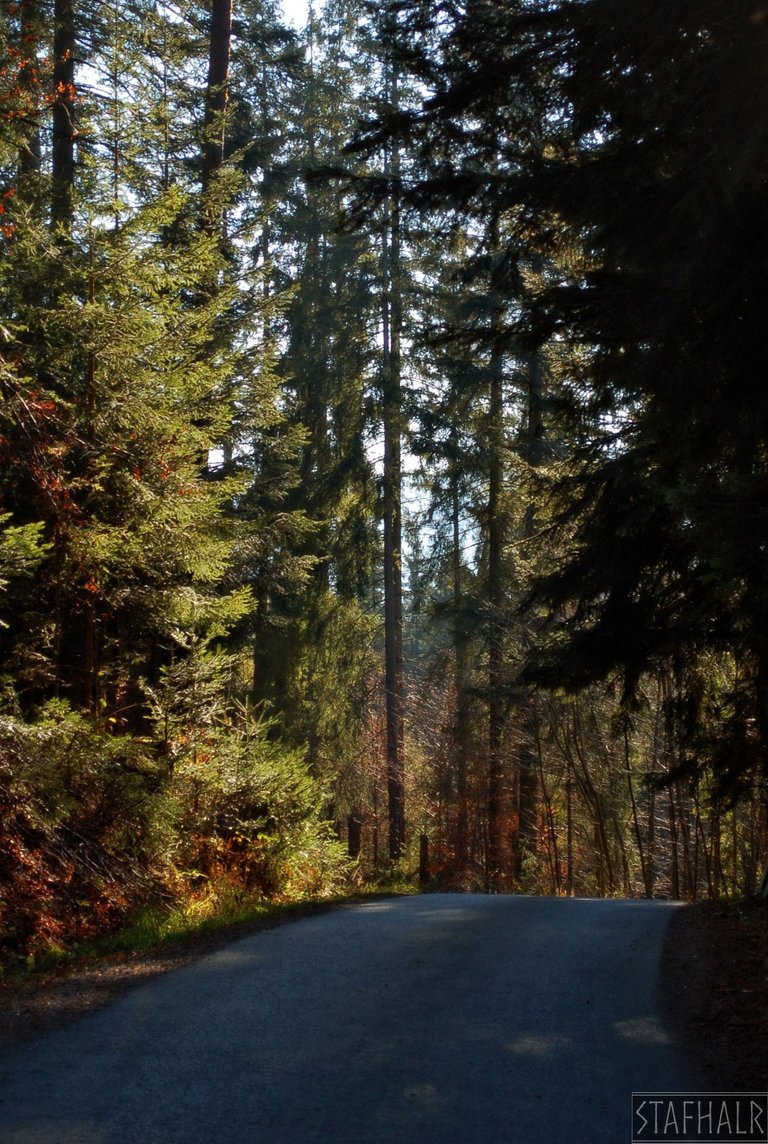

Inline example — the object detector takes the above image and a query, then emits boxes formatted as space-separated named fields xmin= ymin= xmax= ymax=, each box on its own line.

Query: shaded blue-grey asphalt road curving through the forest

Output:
xmin=0 ymin=893 xmax=689 ymax=1144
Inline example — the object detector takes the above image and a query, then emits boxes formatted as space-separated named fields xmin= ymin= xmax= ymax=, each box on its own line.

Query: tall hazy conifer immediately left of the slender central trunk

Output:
xmin=211 ymin=3 xmax=378 ymax=846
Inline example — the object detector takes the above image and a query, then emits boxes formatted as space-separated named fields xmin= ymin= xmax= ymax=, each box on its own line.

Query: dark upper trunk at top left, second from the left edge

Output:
xmin=50 ymin=0 xmax=77 ymax=229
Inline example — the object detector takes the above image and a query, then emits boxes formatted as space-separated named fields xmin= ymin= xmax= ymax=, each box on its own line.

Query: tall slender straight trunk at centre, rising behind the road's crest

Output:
xmin=382 ymin=35 xmax=405 ymax=863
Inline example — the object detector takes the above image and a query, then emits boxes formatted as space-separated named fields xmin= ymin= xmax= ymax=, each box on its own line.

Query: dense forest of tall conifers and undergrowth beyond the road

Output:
xmin=0 ymin=0 xmax=768 ymax=960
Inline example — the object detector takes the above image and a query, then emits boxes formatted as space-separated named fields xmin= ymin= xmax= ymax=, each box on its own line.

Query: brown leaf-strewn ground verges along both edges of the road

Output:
xmin=0 ymin=901 xmax=768 ymax=1091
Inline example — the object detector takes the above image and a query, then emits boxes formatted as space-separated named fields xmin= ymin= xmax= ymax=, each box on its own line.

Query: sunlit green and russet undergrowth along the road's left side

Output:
xmin=0 ymin=686 xmax=384 ymax=972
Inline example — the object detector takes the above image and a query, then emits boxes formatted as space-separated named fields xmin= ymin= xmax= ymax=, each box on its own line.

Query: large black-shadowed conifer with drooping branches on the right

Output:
xmin=368 ymin=0 xmax=766 ymax=819
